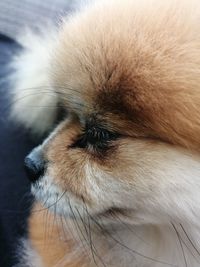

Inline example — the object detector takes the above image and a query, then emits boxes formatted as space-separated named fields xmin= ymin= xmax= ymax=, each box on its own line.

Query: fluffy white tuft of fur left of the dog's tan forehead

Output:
xmin=10 ymin=29 xmax=58 ymax=135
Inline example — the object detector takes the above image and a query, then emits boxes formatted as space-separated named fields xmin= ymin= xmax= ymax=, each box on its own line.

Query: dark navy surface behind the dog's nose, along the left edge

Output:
xmin=0 ymin=35 xmax=35 ymax=267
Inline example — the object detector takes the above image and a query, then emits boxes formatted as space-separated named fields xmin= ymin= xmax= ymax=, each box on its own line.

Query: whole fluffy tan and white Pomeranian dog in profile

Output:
xmin=12 ymin=0 xmax=200 ymax=267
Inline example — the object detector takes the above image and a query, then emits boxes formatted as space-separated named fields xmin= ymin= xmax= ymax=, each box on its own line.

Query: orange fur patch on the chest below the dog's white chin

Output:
xmin=29 ymin=204 xmax=86 ymax=267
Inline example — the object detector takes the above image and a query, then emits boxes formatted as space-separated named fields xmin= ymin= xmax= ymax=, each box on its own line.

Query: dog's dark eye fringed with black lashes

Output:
xmin=73 ymin=126 xmax=119 ymax=149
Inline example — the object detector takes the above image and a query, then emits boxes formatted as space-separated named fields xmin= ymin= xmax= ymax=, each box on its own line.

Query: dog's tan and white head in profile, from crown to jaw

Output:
xmin=23 ymin=1 xmax=200 ymax=228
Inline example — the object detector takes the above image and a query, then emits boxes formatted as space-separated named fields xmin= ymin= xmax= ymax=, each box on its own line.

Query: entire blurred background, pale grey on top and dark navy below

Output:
xmin=0 ymin=0 xmax=76 ymax=267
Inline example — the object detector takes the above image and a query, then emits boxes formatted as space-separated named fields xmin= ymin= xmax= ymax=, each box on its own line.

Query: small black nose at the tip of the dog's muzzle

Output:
xmin=24 ymin=156 xmax=44 ymax=183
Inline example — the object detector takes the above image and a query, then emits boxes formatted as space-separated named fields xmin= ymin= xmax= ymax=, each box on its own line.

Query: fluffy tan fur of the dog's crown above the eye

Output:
xmin=51 ymin=0 xmax=200 ymax=149
